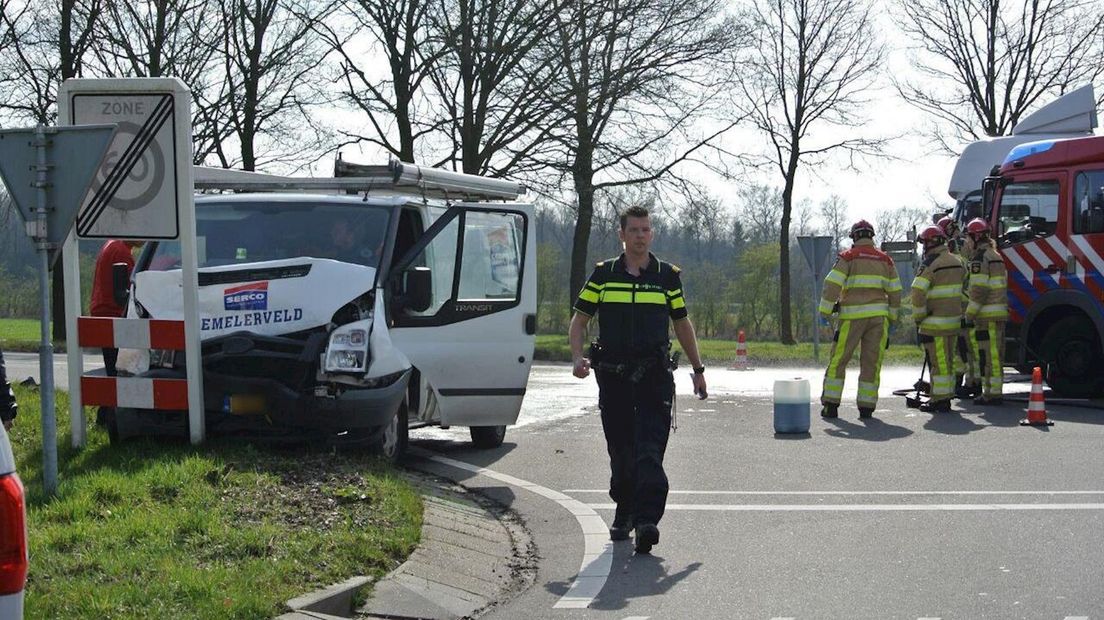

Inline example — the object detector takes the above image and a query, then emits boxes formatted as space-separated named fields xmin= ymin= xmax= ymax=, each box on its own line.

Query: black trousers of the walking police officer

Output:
xmin=595 ymin=366 xmax=675 ymax=525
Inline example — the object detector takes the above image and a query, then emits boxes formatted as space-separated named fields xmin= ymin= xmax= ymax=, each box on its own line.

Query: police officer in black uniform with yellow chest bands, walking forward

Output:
xmin=569 ymin=206 xmax=705 ymax=553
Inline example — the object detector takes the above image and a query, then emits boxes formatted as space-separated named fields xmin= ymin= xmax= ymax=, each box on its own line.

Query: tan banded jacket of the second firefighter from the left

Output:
xmin=912 ymin=245 xmax=966 ymax=335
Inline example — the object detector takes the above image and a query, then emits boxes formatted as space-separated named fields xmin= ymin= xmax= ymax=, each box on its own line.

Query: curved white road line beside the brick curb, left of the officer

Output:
xmin=410 ymin=448 xmax=614 ymax=609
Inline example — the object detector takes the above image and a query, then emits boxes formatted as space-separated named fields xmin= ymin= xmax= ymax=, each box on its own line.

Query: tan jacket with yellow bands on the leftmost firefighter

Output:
xmin=817 ymin=238 xmax=901 ymax=321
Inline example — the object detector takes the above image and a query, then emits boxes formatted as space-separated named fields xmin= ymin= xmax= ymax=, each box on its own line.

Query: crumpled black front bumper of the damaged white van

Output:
xmin=203 ymin=370 xmax=411 ymax=431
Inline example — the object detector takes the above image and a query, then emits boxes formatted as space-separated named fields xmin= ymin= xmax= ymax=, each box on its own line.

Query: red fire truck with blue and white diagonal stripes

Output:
xmin=983 ymin=137 xmax=1104 ymax=397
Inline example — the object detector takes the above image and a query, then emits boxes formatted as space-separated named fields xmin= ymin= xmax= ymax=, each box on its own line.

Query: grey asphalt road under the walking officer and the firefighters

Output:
xmin=413 ymin=366 xmax=1104 ymax=620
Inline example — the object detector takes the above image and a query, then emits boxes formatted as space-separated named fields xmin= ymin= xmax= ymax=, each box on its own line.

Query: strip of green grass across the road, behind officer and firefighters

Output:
xmin=533 ymin=334 xmax=924 ymax=366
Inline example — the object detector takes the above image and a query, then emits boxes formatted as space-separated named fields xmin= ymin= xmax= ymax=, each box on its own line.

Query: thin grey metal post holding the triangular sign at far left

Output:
xmin=34 ymin=125 xmax=57 ymax=495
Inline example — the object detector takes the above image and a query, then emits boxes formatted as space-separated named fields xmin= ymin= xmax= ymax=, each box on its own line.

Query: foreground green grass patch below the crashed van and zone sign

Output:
xmin=11 ymin=386 xmax=422 ymax=619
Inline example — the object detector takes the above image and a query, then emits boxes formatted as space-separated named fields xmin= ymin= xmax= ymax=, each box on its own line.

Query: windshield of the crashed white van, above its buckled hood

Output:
xmin=146 ymin=201 xmax=391 ymax=270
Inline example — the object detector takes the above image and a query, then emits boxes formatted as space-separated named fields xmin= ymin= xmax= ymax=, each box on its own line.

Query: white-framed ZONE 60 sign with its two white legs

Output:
xmin=57 ymin=77 xmax=205 ymax=448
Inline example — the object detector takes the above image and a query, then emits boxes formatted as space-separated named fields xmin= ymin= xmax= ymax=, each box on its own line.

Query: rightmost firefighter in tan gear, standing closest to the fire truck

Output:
xmin=966 ymin=217 xmax=1008 ymax=405
